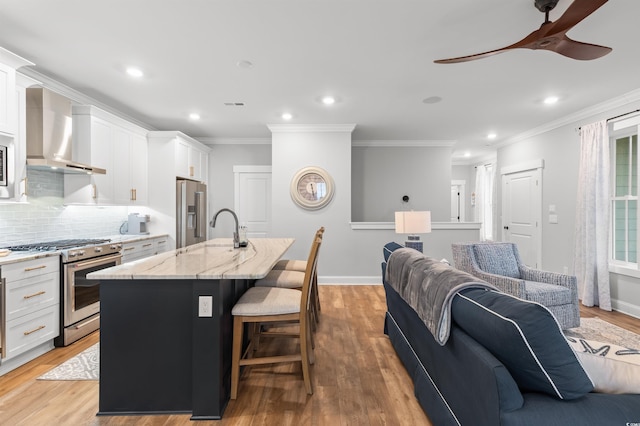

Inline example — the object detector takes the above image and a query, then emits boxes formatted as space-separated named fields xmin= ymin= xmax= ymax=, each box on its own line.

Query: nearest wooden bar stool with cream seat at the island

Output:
xmin=231 ymin=233 xmax=322 ymax=399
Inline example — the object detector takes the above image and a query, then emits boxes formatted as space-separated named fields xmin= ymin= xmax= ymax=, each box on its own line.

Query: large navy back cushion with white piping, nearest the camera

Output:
xmin=452 ymin=289 xmax=593 ymax=399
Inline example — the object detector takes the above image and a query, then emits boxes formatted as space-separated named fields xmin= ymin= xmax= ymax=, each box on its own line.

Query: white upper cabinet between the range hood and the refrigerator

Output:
xmin=64 ymin=105 xmax=148 ymax=206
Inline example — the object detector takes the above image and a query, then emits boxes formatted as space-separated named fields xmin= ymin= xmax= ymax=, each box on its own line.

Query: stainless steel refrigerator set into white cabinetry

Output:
xmin=176 ymin=180 xmax=207 ymax=248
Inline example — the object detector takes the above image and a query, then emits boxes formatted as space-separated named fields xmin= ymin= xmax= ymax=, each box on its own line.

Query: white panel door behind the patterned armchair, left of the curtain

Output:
xmin=502 ymin=169 xmax=542 ymax=268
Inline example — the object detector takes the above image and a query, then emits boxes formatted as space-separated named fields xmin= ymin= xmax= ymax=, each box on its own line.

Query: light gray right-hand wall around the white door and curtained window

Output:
xmin=497 ymin=102 xmax=640 ymax=316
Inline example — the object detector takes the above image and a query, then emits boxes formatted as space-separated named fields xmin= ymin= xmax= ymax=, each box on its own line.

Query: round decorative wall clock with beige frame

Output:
xmin=291 ymin=167 xmax=334 ymax=210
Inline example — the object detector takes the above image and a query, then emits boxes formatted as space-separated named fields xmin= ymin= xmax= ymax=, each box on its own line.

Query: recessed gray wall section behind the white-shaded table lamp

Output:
xmin=351 ymin=146 xmax=451 ymax=222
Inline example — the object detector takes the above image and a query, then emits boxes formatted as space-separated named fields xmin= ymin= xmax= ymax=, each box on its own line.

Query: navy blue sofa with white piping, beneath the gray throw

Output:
xmin=382 ymin=243 xmax=640 ymax=426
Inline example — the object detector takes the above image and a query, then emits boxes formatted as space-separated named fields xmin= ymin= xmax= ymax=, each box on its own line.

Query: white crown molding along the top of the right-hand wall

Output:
xmin=491 ymin=89 xmax=640 ymax=148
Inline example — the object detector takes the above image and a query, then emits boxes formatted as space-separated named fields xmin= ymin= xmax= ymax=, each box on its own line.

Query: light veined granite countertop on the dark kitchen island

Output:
xmin=88 ymin=238 xmax=295 ymax=280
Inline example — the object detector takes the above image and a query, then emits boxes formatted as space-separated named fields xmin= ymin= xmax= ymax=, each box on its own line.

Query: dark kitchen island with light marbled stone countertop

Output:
xmin=90 ymin=238 xmax=294 ymax=420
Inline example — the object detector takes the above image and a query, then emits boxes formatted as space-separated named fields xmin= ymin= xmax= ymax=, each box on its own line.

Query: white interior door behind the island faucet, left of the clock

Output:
xmin=233 ymin=166 xmax=271 ymax=238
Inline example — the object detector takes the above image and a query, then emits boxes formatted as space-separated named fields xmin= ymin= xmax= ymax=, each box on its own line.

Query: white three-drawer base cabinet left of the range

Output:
xmin=0 ymin=256 xmax=60 ymax=360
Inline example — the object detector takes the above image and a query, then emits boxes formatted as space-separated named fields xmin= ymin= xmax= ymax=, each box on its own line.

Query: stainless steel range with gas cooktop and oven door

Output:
xmin=7 ymin=239 xmax=122 ymax=346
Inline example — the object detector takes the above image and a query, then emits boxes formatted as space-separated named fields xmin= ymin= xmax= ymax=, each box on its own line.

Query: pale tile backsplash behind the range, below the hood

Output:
xmin=0 ymin=169 xmax=128 ymax=247
